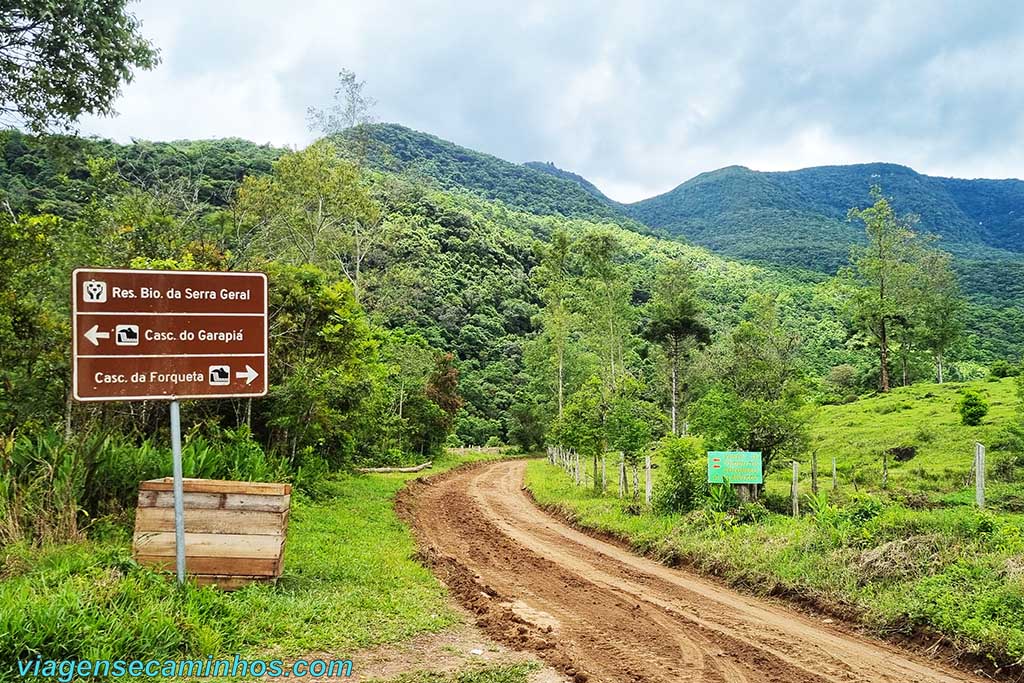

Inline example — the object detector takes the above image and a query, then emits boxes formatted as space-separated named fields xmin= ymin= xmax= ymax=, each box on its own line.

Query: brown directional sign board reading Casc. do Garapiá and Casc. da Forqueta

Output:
xmin=72 ymin=268 xmax=267 ymax=400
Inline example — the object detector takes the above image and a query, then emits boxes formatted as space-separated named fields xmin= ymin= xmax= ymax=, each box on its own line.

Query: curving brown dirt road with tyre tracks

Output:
xmin=398 ymin=461 xmax=982 ymax=683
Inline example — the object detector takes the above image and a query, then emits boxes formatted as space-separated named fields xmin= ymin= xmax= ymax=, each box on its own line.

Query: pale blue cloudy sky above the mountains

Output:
xmin=80 ymin=0 xmax=1024 ymax=202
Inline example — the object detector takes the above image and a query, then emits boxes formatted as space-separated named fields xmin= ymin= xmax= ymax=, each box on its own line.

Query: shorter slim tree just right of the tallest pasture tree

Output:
xmin=920 ymin=250 xmax=966 ymax=384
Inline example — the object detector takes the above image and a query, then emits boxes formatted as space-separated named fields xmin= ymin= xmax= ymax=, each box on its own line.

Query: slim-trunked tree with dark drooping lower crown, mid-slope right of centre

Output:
xmin=647 ymin=261 xmax=711 ymax=435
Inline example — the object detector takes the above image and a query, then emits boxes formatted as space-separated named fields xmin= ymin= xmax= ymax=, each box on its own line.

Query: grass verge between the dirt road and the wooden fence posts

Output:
xmin=526 ymin=460 xmax=1024 ymax=668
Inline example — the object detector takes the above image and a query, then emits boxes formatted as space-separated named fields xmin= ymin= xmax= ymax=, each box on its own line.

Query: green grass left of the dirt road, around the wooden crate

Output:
xmin=0 ymin=455 xmax=499 ymax=681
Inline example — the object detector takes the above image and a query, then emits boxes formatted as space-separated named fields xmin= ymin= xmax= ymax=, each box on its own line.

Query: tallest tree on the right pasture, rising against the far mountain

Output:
xmin=844 ymin=185 xmax=918 ymax=391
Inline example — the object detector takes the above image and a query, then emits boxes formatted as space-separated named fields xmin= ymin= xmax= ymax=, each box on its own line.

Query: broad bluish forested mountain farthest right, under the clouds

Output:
xmin=626 ymin=164 xmax=1024 ymax=272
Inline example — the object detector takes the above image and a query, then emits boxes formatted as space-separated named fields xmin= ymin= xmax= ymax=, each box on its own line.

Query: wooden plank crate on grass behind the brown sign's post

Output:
xmin=132 ymin=477 xmax=292 ymax=590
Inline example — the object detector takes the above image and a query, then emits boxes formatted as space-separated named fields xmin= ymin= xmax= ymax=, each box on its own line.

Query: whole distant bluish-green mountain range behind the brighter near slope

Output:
xmin=346 ymin=124 xmax=1024 ymax=308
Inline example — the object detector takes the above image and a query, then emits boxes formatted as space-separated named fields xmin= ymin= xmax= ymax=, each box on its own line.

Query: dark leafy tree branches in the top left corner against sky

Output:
xmin=0 ymin=0 xmax=159 ymax=133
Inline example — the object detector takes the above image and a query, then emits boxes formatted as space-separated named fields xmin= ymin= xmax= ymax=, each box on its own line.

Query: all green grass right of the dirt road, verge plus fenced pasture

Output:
xmin=526 ymin=380 xmax=1024 ymax=665
